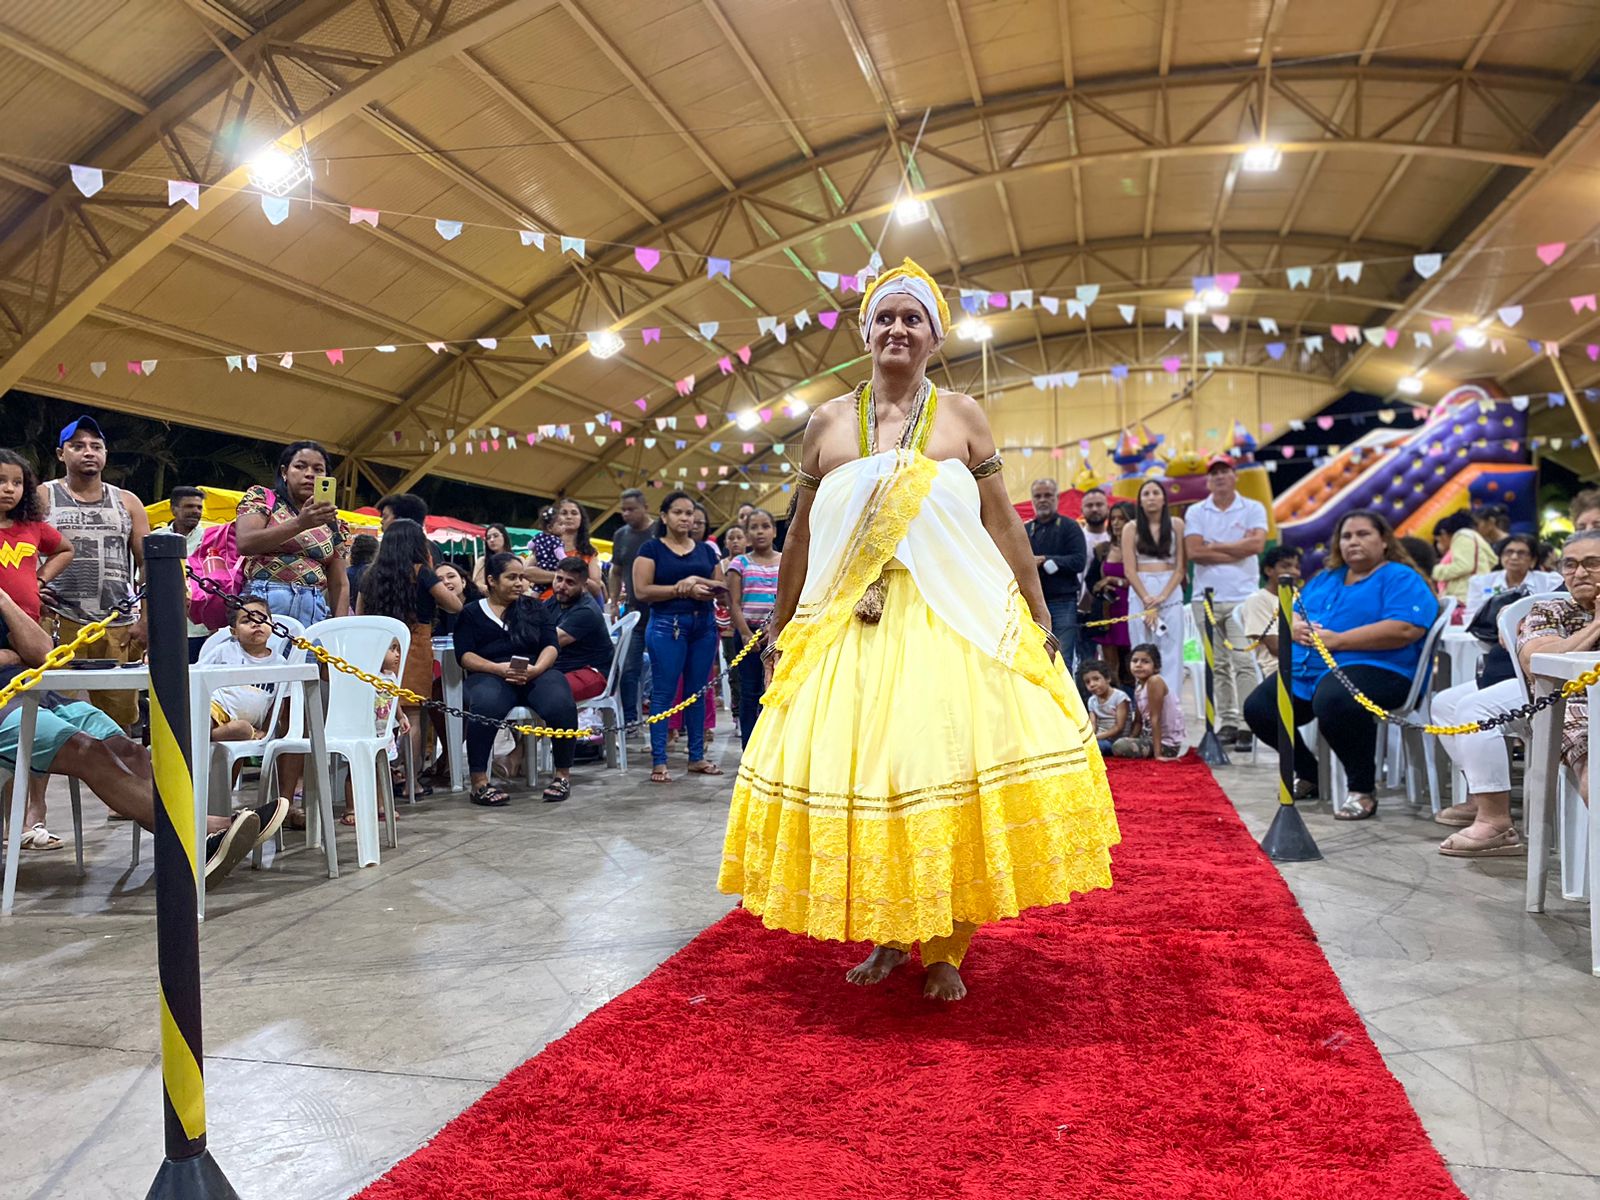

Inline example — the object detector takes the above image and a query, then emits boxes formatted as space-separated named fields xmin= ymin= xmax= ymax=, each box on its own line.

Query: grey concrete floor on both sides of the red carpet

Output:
xmin=0 ymin=729 xmax=1600 ymax=1200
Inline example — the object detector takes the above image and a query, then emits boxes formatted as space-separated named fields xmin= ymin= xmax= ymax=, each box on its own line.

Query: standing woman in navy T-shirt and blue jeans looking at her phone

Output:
xmin=634 ymin=491 xmax=728 ymax=784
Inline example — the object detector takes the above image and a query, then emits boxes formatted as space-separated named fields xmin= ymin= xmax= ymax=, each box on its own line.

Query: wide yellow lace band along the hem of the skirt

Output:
xmin=718 ymin=754 xmax=1122 ymax=942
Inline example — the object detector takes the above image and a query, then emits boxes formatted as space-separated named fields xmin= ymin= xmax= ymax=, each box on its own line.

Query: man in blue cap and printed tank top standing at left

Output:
xmin=38 ymin=416 xmax=150 ymax=730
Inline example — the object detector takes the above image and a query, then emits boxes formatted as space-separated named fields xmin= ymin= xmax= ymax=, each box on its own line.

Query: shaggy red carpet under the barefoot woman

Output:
xmin=362 ymin=758 xmax=1461 ymax=1200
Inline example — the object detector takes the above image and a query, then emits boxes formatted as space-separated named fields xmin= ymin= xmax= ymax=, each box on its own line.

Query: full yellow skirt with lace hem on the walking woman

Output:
xmin=718 ymin=568 xmax=1120 ymax=944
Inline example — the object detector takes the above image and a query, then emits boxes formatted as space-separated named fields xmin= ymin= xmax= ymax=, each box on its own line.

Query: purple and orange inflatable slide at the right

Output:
xmin=1267 ymin=384 xmax=1538 ymax=560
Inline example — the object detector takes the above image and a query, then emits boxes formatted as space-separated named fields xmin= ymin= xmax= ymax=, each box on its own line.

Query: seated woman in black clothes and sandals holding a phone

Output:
xmin=454 ymin=554 xmax=578 ymax=808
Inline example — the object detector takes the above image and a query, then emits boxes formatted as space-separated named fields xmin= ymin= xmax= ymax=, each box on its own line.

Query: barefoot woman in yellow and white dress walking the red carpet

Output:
xmin=718 ymin=259 xmax=1120 ymax=1000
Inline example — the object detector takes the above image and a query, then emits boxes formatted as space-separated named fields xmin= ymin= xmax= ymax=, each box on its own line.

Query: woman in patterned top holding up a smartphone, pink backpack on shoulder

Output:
xmin=234 ymin=442 xmax=350 ymax=626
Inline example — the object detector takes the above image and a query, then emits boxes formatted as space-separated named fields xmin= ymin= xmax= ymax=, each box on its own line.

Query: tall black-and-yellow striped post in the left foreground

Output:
xmin=144 ymin=533 xmax=238 ymax=1200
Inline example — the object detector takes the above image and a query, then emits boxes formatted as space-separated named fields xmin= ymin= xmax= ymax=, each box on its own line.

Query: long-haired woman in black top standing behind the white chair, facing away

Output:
xmin=355 ymin=517 xmax=462 ymax=795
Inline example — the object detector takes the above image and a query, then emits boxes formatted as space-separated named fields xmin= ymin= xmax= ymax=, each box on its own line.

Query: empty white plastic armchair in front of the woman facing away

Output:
xmin=261 ymin=616 xmax=411 ymax=867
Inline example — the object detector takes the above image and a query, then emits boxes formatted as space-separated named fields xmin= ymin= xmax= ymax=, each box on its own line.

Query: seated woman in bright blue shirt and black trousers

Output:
xmin=1245 ymin=509 xmax=1438 ymax=821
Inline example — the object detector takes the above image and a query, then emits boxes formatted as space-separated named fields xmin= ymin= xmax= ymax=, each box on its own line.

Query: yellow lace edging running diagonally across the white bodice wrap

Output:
xmin=762 ymin=450 xmax=934 ymax=706
